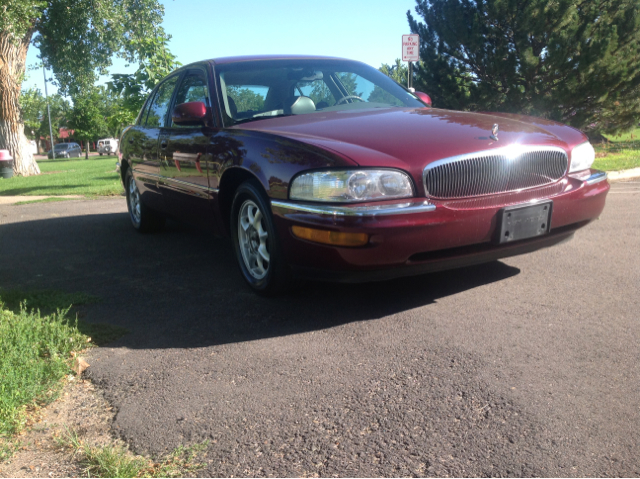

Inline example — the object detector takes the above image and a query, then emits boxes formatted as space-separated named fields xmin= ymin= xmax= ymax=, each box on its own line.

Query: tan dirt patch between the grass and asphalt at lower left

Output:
xmin=0 ymin=379 xmax=115 ymax=477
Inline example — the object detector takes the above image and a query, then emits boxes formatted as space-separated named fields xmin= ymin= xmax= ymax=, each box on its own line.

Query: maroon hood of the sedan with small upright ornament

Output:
xmin=233 ymin=108 xmax=586 ymax=173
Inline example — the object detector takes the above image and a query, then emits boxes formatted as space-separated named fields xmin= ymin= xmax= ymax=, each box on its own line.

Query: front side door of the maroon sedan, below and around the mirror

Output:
xmin=160 ymin=68 xmax=216 ymax=228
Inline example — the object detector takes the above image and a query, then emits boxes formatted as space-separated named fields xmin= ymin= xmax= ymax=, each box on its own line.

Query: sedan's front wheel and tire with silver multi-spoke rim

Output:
xmin=230 ymin=180 xmax=291 ymax=296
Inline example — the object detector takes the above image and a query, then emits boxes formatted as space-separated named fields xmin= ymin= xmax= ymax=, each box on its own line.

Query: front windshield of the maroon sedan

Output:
xmin=216 ymin=60 xmax=424 ymax=126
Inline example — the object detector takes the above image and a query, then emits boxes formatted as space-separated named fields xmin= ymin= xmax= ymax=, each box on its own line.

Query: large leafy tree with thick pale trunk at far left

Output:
xmin=0 ymin=0 xmax=167 ymax=175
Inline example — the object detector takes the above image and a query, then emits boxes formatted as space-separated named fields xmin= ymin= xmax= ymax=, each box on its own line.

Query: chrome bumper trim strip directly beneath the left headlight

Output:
xmin=271 ymin=200 xmax=436 ymax=216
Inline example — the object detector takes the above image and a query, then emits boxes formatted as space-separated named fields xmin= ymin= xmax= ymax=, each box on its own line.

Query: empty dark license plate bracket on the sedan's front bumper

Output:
xmin=497 ymin=201 xmax=553 ymax=244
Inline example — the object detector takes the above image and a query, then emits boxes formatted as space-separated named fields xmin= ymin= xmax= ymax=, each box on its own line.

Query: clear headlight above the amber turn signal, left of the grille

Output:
xmin=289 ymin=170 xmax=413 ymax=203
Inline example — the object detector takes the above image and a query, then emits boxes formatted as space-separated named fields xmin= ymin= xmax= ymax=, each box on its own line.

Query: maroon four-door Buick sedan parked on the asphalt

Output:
xmin=120 ymin=56 xmax=609 ymax=294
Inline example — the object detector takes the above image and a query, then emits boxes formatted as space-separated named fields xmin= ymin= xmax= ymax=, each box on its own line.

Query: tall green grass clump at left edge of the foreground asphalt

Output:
xmin=0 ymin=289 xmax=127 ymax=463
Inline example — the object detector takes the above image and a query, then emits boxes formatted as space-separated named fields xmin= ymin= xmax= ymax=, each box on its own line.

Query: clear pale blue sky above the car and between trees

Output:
xmin=23 ymin=0 xmax=416 ymax=94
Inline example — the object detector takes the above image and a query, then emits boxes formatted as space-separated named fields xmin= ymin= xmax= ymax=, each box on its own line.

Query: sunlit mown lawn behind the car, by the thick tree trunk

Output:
xmin=0 ymin=156 xmax=123 ymax=196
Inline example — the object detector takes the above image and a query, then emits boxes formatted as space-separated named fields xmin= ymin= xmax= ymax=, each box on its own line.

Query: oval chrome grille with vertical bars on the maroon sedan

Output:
xmin=424 ymin=146 xmax=569 ymax=199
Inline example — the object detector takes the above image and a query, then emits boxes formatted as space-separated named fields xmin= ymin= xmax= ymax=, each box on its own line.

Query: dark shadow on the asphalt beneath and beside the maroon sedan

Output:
xmin=0 ymin=213 xmax=519 ymax=349
